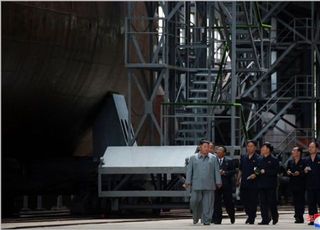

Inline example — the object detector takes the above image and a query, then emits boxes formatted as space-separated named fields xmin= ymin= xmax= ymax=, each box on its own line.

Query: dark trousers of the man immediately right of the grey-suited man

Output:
xmin=212 ymin=187 xmax=235 ymax=223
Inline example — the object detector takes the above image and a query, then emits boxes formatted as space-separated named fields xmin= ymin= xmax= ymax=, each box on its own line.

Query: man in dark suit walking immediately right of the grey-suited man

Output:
xmin=212 ymin=146 xmax=236 ymax=224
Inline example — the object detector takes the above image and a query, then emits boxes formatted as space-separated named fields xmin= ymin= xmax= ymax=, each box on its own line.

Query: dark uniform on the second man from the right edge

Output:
xmin=287 ymin=159 xmax=306 ymax=223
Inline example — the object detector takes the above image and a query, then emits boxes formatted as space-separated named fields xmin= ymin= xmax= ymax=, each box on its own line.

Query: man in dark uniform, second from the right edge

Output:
xmin=287 ymin=147 xmax=305 ymax=223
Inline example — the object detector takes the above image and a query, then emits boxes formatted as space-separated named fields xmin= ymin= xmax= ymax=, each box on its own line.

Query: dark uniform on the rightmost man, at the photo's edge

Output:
xmin=305 ymin=154 xmax=320 ymax=221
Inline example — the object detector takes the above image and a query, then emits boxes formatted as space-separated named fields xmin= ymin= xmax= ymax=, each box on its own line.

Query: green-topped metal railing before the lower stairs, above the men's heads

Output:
xmin=161 ymin=102 xmax=245 ymax=149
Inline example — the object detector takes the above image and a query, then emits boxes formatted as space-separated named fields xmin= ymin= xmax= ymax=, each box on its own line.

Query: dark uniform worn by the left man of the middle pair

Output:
xmin=239 ymin=153 xmax=261 ymax=223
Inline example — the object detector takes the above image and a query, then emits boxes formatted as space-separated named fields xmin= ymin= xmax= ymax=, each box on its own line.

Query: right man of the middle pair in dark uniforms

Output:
xmin=256 ymin=142 xmax=279 ymax=225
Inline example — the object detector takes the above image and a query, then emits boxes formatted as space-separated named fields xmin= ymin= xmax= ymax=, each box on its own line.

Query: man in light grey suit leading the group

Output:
xmin=185 ymin=140 xmax=222 ymax=225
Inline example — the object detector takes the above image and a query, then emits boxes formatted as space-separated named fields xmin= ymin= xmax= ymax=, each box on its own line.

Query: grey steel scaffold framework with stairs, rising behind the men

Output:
xmin=125 ymin=2 xmax=320 ymax=154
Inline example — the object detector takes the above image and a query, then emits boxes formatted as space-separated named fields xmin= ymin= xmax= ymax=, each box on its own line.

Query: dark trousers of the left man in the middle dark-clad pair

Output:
xmin=240 ymin=188 xmax=258 ymax=222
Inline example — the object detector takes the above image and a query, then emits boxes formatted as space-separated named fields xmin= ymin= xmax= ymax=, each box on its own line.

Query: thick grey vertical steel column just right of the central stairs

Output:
xmin=230 ymin=1 xmax=237 ymax=156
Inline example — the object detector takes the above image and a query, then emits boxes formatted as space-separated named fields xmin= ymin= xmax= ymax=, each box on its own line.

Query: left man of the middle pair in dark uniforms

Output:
xmin=237 ymin=140 xmax=260 ymax=224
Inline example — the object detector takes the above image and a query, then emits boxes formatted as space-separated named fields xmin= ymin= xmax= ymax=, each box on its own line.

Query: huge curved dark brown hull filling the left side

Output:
xmin=1 ymin=2 xmax=145 ymax=216
